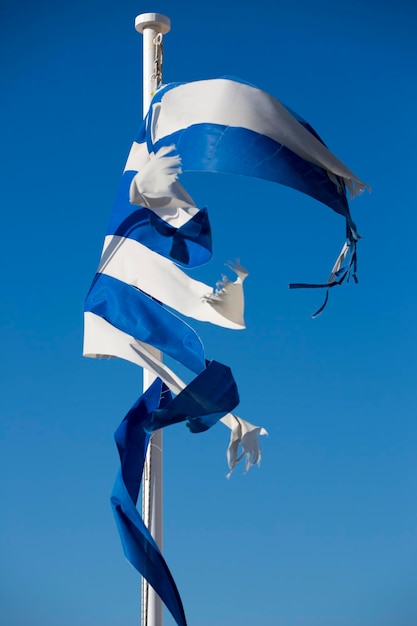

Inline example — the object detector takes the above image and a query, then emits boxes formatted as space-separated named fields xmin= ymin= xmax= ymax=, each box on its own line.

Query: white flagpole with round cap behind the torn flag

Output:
xmin=135 ymin=13 xmax=171 ymax=626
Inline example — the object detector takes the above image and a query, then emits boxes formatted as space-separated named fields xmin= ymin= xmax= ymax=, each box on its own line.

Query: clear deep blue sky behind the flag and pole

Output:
xmin=0 ymin=0 xmax=417 ymax=626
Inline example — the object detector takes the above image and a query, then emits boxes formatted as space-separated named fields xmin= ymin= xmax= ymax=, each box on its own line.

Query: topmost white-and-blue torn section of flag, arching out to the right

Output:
xmin=132 ymin=77 xmax=370 ymax=317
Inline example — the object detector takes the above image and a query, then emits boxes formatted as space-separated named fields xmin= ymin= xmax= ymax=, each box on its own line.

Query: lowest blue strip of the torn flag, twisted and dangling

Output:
xmin=111 ymin=361 xmax=239 ymax=626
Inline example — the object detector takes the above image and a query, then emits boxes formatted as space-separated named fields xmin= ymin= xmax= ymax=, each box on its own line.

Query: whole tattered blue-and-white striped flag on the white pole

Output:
xmin=83 ymin=77 xmax=367 ymax=626
